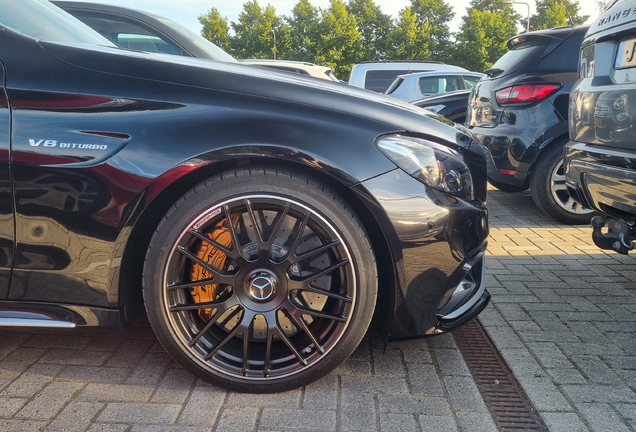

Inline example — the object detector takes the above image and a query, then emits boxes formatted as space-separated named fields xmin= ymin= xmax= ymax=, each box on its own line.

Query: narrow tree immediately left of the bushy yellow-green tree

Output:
xmin=411 ymin=0 xmax=455 ymax=61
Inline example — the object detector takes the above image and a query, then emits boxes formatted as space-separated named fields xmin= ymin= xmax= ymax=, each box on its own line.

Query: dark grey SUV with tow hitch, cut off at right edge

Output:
xmin=565 ymin=0 xmax=636 ymax=254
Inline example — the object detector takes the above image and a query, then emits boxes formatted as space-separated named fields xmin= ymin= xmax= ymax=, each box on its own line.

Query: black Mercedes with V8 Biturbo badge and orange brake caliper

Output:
xmin=0 ymin=0 xmax=489 ymax=392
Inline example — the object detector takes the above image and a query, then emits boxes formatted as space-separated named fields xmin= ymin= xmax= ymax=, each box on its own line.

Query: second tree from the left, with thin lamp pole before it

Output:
xmin=230 ymin=0 xmax=289 ymax=58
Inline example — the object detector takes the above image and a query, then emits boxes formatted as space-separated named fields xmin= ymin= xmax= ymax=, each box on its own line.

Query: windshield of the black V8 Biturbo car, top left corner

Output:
xmin=0 ymin=0 xmax=115 ymax=46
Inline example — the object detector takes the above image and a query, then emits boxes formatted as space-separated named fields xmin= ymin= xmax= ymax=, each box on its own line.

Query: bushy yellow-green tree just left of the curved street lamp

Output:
xmin=454 ymin=0 xmax=520 ymax=72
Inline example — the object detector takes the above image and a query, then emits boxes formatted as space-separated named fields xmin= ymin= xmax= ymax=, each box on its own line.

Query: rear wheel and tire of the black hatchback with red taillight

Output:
xmin=530 ymin=144 xmax=595 ymax=225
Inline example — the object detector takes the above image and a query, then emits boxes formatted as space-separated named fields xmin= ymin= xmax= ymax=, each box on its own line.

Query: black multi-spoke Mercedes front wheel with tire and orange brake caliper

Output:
xmin=143 ymin=168 xmax=378 ymax=393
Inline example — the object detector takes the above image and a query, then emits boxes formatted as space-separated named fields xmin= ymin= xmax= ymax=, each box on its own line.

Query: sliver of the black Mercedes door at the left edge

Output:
xmin=0 ymin=61 xmax=15 ymax=299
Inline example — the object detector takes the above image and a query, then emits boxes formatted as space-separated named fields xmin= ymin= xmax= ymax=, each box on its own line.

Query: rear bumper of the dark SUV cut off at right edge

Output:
xmin=564 ymin=142 xmax=636 ymax=222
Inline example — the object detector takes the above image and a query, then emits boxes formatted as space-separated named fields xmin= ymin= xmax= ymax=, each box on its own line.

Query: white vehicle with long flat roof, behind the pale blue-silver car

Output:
xmin=349 ymin=60 xmax=468 ymax=93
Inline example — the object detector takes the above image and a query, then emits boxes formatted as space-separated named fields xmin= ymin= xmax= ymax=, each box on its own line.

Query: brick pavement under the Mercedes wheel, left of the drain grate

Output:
xmin=0 ymin=310 xmax=496 ymax=432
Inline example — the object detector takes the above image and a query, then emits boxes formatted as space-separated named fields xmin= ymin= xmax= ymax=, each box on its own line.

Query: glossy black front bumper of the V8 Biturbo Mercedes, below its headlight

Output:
xmin=354 ymin=170 xmax=490 ymax=339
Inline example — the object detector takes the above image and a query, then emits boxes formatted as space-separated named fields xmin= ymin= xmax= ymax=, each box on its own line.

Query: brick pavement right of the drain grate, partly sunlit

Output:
xmin=480 ymin=186 xmax=636 ymax=432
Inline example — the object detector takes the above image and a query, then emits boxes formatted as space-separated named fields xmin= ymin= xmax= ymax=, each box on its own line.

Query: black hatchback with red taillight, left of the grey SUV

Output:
xmin=466 ymin=26 xmax=592 ymax=224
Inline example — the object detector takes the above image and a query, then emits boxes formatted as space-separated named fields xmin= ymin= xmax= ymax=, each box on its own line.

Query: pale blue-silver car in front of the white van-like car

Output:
xmin=385 ymin=71 xmax=483 ymax=102
